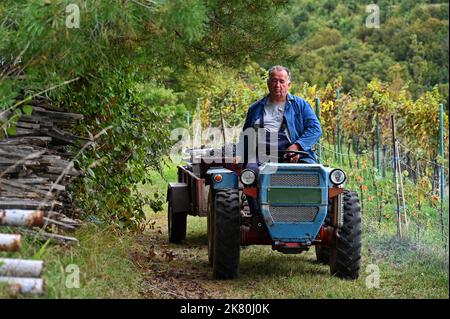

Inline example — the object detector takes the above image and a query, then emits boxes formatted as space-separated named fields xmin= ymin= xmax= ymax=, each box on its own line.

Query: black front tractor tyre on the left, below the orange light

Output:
xmin=211 ymin=189 xmax=241 ymax=279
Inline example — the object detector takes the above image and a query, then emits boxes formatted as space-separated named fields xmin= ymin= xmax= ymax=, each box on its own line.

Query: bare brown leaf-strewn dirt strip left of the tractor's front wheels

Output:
xmin=132 ymin=216 xmax=224 ymax=299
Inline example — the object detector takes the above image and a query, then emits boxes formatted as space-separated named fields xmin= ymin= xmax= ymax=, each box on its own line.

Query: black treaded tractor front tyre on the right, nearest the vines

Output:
xmin=330 ymin=190 xmax=361 ymax=279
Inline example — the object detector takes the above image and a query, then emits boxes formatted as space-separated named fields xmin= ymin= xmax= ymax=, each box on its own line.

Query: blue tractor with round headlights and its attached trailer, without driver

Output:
xmin=167 ymin=149 xmax=361 ymax=279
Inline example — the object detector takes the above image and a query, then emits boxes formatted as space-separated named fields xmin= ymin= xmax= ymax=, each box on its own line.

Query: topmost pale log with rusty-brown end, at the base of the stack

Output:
xmin=0 ymin=209 xmax=44 ymax=227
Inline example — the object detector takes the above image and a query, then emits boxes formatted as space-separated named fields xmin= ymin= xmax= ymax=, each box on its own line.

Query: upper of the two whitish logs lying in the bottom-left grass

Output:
xmin=0 ymin=258 xmax=44 ymax=278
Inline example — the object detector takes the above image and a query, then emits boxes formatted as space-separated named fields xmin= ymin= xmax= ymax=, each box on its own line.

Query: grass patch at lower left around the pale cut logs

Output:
xmin=0 ymin=225 xmax=142 ymax=299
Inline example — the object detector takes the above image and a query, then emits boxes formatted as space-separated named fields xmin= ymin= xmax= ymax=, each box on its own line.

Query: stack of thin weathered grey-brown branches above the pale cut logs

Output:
xmin=0 ymin=102 xmax=83 ymax=229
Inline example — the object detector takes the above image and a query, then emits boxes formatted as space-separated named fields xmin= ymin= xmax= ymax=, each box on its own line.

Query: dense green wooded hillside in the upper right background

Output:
xmin=284 ymin=0 xmax=449 ymax=98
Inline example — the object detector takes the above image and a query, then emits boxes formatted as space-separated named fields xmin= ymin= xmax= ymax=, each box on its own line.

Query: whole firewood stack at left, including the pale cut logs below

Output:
xmin=0 ymin=100 xmax=88 ymax=293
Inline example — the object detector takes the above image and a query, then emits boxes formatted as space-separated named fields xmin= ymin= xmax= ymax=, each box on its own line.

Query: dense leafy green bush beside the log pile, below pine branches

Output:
xmin=70 ymin=70 xmax=170 ymax=229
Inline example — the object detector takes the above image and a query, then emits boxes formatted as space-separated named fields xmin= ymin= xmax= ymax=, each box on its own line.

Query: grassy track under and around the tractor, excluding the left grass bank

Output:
xmin=135 ymin=212 xmax=448 ymax=299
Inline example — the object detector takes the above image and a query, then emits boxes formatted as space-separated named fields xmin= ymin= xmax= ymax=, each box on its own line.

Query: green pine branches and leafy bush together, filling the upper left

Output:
xmin=0 ymin=0 xmax=286 ymax=229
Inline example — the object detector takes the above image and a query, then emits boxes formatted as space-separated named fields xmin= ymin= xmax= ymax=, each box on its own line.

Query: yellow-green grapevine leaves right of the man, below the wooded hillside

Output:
xmin=293 ymin=78 xmax=449 ymax=164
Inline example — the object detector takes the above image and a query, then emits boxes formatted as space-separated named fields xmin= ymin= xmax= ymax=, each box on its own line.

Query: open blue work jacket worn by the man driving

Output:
xmin=243 ymin=94 xmax=322 ymax=162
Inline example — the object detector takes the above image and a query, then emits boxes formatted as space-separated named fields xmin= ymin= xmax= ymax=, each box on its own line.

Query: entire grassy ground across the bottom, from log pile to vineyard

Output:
xmin=0 ymin=162 xmax=449 ymax=299
